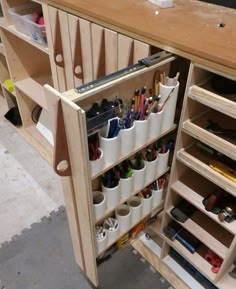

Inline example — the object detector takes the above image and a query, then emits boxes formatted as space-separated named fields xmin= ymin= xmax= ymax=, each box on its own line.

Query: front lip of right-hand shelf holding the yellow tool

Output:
xmin=177 ymin=150 xmax=236 ymax=196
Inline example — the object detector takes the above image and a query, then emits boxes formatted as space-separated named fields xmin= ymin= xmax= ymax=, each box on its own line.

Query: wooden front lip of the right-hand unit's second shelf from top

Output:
xmin=183 ymin=120 xmax=236 ymax=160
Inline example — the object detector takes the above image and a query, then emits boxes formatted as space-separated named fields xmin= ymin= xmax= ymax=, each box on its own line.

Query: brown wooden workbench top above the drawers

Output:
xmin=43 ymin=0 xmax=236 ymax=69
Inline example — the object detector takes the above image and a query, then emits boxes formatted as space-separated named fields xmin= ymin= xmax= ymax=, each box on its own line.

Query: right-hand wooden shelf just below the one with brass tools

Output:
xmin=167 ymin=206 xmax=233 ymax=259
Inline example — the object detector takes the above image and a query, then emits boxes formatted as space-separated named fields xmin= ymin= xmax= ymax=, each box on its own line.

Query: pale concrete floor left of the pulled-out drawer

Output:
xmin=0 ymin=96 xmax=64 ymax=246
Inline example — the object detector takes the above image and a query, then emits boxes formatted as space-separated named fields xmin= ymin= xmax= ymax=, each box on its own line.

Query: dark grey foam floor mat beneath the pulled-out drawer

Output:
xmin=0 ymin=207 xmax=169 ymax=289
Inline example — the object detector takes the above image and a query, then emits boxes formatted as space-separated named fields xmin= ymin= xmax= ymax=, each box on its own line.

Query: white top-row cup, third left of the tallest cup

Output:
xmin=119 ymin=122 xmax=136 ymax=155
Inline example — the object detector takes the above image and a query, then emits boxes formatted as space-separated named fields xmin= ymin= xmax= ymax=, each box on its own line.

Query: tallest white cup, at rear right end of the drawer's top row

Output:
xmin=159 ymin=78 xmax=179 ymax=132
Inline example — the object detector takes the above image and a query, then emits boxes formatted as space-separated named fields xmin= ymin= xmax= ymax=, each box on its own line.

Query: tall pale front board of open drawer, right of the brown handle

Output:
xmin=62 ymin=96 xmax=98 ymax=286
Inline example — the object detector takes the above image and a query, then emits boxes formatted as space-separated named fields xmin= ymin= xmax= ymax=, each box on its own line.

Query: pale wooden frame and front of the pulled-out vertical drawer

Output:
xmin=45 ymin=52 xmax=177 ymax=286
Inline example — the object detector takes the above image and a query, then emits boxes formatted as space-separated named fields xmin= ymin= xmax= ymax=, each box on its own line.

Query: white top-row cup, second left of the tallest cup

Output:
xmin=135 ymin=118 xmax=150 ymax=146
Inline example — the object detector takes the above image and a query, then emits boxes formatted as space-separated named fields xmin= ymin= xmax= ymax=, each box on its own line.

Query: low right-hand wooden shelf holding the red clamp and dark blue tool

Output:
xmin=162 ymin=234 xmax=216 ymax=281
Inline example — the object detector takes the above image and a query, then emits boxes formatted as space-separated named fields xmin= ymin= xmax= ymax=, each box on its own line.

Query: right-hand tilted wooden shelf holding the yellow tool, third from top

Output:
xmin=177 ymin=146 xmax=236 ymax=196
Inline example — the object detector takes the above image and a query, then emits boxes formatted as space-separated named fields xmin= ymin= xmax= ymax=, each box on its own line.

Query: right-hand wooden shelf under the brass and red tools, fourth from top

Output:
xmin=171 ymin=176 xmax=236 ymax=235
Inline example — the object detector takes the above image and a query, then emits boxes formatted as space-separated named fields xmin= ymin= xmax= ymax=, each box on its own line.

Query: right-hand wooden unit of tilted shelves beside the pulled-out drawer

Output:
xmin=161 ymin=64 xmax=236 ymax=289
